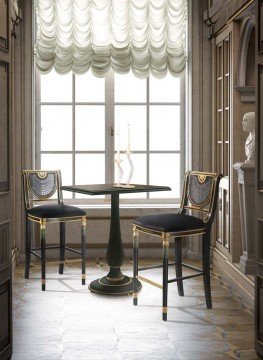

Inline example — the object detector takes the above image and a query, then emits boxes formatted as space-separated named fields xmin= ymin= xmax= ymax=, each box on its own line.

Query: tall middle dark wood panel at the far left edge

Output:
xmin=0 ymin=60 xmax=9 ymax=192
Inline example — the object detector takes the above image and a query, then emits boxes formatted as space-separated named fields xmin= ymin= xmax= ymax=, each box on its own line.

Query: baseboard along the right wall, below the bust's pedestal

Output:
xmin=212 ymin=248 xmax=255 ymax=309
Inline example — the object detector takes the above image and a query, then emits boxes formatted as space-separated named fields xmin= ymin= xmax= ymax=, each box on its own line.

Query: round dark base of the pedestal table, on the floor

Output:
xmin=89 ymin=275 xmax=142 ymax=295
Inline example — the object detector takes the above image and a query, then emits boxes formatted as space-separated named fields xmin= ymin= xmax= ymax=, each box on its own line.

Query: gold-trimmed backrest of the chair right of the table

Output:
xmin=179 ymin=171 xmax=222 ymax=224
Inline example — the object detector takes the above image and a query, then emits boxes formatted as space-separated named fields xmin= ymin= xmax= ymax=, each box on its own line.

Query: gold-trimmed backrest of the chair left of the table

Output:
xmin=22 ymin=170 xmax=63 ymax=209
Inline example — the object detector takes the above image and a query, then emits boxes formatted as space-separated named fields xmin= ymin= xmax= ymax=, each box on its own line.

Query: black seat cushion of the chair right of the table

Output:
xmin=133 ymin=214 xmax=205 ymax=232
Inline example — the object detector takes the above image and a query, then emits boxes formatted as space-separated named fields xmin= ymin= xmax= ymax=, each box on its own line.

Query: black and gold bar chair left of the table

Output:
xmin=22 ymin=170 xmax=86 ymax=291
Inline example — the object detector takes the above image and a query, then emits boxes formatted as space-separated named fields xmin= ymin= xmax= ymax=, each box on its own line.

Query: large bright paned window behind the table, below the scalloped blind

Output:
xmin=35 ymin=70 xmax=184 ymax=203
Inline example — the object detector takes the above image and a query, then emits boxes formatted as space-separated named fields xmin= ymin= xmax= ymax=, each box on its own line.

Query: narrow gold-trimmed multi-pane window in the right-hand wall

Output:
xmin=214 ymin=29 xmax=232 ymax=255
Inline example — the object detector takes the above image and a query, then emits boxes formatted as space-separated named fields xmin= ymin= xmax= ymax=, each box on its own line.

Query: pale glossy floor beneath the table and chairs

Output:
xmin=12 ymin=261 xmax=257 ymax=360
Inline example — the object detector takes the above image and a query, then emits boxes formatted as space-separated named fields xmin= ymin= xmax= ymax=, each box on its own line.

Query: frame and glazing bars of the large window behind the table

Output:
xmin=33 ymin=68 xmax=189 ymax=207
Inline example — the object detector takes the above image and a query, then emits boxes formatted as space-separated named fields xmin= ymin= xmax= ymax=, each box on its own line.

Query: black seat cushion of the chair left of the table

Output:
xmin=28 ymin=204 xmax=86 ymax=219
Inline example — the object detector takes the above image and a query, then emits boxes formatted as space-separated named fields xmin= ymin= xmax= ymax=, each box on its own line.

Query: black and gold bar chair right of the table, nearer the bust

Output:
xmin=133 ymin=171 xmax=222 ymax=321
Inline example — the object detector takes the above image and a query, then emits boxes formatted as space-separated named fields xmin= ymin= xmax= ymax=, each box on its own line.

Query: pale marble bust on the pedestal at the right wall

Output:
xmin=242 ymin=112 xmax=255 ymax=163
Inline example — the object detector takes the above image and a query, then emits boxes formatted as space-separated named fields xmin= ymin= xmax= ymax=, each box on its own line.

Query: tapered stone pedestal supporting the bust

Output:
xmin=234 ymin=162 xmax=255 ymax=274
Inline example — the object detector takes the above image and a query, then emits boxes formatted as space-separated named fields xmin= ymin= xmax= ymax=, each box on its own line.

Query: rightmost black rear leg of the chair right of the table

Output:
xmin=202 ymin=233 xmax=212 ymax=309
